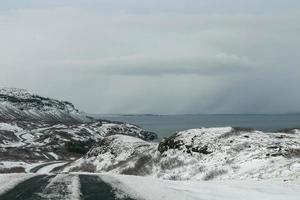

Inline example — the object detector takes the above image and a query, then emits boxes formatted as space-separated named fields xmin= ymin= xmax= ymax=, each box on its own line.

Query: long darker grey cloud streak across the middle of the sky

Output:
xmin=59 ymin=54 xmax=255 ymax=76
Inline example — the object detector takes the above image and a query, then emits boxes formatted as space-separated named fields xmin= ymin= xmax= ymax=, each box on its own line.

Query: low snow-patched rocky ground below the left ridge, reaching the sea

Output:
xmin=0 ymin=121 xmax=155 ymax=160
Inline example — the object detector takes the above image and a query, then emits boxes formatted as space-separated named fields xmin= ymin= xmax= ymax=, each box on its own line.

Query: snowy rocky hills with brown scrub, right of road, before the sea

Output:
xmin=66 ymin=127 xmax=300 ymax=180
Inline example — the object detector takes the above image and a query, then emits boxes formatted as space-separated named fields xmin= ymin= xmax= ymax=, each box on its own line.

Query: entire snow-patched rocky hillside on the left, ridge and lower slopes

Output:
xmin=0 ymin=88 xmax=157 ymax=164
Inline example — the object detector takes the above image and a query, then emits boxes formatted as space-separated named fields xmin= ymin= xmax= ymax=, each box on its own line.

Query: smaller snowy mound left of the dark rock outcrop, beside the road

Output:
xmin=65 ymin=135 xmax=157 ymax=175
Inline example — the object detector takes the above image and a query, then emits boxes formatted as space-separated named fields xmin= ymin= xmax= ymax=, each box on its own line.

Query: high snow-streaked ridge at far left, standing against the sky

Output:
xmin=0 ymin=88 xmax=91 ymax=122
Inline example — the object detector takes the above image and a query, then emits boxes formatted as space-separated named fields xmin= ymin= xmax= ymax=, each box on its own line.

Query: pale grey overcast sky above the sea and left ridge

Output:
xmin=0 ymin=0 xmax=300 ymax=114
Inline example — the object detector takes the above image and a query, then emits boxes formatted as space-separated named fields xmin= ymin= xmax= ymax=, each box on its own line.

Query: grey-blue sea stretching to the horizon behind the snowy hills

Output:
xmin=94 ymin=114 xmax=300 ymax=139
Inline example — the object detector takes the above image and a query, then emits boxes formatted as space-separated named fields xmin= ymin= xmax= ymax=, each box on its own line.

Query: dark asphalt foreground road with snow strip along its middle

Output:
xmin=0 ymin=174 xmax=134 ymax=200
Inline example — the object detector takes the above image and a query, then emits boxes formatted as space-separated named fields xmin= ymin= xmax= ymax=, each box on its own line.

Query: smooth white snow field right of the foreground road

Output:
xmin=101 ymin=175 xmax=300 ymax=200
